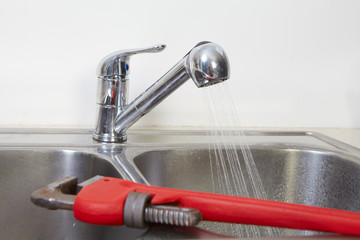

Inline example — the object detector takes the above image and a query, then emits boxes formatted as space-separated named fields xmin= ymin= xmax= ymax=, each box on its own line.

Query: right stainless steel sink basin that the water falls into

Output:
xmin=134 ymin=146 xmax=360 ymax=236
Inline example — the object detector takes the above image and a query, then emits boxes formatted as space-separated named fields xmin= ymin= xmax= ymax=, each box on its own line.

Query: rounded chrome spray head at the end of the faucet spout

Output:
xmin=185 ymin=42 xmax=230 ymax=87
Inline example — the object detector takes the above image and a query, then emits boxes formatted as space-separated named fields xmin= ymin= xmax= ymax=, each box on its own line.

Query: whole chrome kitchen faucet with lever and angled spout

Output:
xmin=93 ymin=42 xmax=230 ymax=142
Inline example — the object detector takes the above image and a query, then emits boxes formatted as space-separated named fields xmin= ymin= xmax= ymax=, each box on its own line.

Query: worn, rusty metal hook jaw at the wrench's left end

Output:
xmin=31 ymin=177 xmax=78 ymax=210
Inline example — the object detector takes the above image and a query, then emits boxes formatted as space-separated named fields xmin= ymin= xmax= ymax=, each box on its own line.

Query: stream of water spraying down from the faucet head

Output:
xmin=203 ymin=82 xmax=279 ymax=237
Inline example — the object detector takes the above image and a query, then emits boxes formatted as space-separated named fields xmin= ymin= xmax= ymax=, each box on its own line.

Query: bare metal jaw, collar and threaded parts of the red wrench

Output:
xmin=31 ymin=176 xmax=201 ymax=228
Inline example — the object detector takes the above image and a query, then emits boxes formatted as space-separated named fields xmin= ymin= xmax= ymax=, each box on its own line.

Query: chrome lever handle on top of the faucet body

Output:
xmin=96 ymin=44 xmax=166 ymax=78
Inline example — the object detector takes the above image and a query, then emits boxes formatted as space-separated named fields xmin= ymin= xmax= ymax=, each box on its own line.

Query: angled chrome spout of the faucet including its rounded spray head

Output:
xmin=115 ymin=42 xmax=230 ymax=138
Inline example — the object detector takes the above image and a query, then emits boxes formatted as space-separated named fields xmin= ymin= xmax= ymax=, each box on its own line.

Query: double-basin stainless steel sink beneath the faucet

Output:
xmin=0 ymin=129 xmax=360 ymax=239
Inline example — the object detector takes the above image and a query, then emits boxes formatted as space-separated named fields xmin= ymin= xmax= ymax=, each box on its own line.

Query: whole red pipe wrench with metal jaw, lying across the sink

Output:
xmin=31 ymin=176 xmax=360 ymax=235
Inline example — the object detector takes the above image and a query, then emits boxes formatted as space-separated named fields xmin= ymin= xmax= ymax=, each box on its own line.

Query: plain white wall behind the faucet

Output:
xmin=0 ymin=0 xmax=360 ymax=128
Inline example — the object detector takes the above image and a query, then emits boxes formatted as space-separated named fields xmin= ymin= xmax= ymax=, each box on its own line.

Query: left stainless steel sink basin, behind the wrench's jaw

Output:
xmin=0 ymin=148 xmax=143 ymax=239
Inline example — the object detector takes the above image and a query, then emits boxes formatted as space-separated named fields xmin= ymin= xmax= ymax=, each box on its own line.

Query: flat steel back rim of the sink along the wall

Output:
xmin=0 ymin=128 xmax=360 ymax=154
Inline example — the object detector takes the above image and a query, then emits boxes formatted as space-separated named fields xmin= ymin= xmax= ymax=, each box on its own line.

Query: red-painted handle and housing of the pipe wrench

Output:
xmin=73 ymin=177 xmax=360 ymax=235
